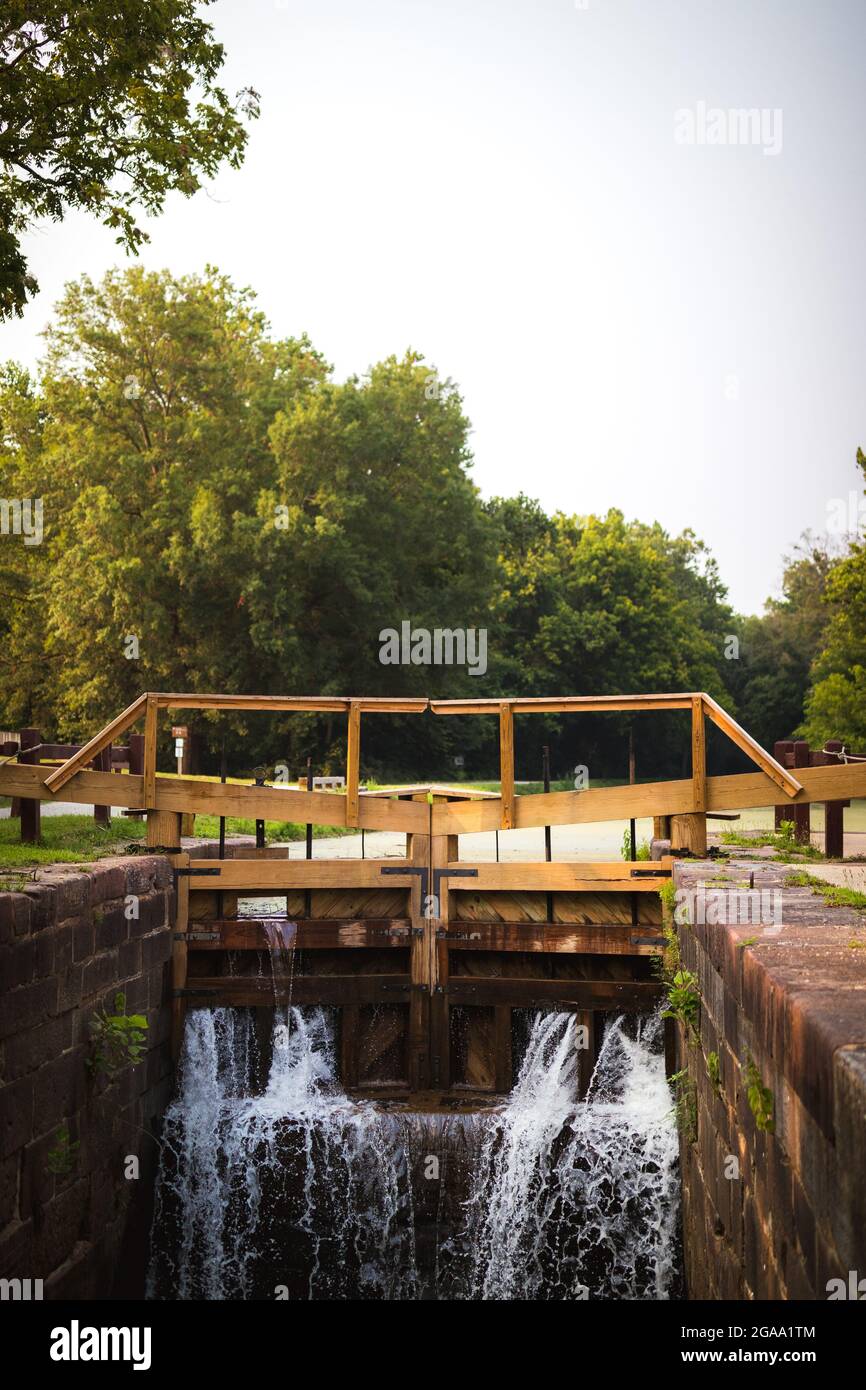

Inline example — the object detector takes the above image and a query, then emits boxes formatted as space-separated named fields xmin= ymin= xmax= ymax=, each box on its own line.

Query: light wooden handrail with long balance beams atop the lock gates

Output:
xmin=6 ymin=692 xmax=866 ymax=852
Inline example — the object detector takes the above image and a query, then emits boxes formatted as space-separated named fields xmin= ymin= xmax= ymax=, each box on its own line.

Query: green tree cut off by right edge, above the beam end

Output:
xmin=802 ymin=449 xmax=866 ymax=753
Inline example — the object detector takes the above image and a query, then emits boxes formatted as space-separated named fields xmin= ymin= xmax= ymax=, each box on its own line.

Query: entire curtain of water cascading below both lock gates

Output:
xmin=149 ymin=1008 xmax=678 ymax=1300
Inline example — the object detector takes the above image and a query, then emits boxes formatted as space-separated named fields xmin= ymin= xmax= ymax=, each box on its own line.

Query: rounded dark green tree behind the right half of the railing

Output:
xmin=489 ymin=498 xmax=731 ymax=776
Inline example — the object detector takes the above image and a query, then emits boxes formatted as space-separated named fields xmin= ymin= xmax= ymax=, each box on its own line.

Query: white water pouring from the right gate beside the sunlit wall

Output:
xmin=463 ymin=1013 xmax=678 ymax=1300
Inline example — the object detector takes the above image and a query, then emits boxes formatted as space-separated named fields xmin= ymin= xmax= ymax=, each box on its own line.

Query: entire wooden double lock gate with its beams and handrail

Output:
xmin=0 ymin=692 xmax=866 ymax=1093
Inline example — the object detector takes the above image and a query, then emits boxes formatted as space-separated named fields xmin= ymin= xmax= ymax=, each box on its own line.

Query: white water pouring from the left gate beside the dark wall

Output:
xmin=149 ymin=1008 xmax=416 ymax=1298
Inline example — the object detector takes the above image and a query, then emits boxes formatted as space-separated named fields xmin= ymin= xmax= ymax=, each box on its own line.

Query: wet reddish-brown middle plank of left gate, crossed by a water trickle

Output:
xmin=181 ymin=917 xmax=411 ymax=951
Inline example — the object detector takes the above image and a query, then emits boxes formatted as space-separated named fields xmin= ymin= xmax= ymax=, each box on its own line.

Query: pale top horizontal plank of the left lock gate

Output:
xmin=189 ymin=859 xmax=417 ymax=892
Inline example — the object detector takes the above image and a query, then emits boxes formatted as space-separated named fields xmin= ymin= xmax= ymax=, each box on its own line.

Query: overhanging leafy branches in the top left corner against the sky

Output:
xmin=0 ymin=0 xmax=257 ymax=317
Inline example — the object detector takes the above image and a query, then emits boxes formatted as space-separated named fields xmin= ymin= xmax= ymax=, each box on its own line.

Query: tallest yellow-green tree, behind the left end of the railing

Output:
xmin=0 ymin=267 xmax=327 ymax=735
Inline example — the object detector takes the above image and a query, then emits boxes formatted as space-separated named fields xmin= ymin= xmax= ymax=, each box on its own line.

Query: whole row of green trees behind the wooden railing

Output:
xmin=0 ymin=267 xmax=866 ymax=778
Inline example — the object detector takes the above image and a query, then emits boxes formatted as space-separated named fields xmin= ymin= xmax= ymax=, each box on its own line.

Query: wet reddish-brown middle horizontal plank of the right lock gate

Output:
xmin=445 ymin=919 xmax=664 ymax=955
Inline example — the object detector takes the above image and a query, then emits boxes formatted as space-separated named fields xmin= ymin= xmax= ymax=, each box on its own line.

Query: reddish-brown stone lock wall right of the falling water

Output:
xmin=676 ymin=863 xmax=866 ymax=1300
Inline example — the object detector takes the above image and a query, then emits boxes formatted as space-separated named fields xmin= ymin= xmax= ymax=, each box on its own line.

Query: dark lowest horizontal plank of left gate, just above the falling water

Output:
xmin=186 ymin=974 xmax=411 ymax=1009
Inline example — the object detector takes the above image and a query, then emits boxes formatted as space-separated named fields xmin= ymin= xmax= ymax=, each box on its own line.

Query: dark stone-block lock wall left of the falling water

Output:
xmin=0 ymin=855 xmax=175 ymax=1298
